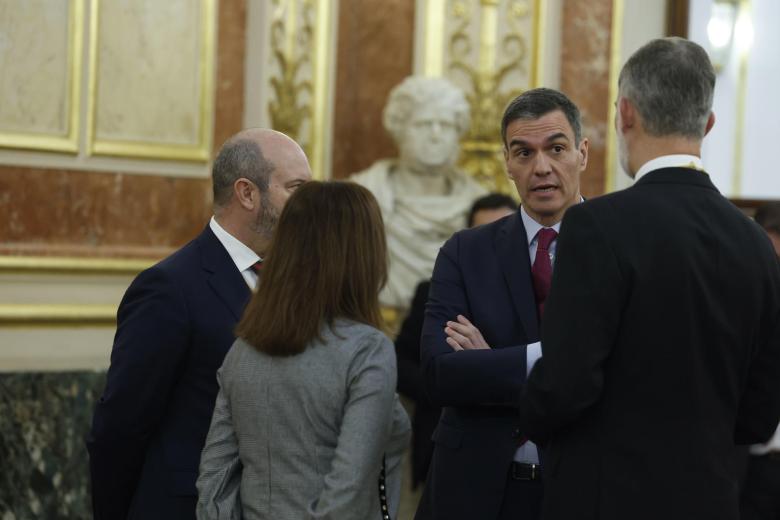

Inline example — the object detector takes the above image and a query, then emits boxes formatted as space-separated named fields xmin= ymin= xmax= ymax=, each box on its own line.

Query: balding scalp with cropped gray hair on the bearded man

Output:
xmin=212 ymin=128 xmax=311 ymax=208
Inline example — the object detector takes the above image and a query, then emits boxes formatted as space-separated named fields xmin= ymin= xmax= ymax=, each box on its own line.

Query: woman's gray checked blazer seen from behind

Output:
xmin=197 ymin=320 xmax=410 ymax=520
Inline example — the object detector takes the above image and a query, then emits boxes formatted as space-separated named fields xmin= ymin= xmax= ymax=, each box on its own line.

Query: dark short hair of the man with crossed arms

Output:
xmin=501 ymin=88 xmax=582 ymax=146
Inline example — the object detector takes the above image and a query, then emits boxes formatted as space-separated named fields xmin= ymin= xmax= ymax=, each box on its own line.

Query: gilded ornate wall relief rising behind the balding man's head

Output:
xmin=245 ymin=0 xmax=337 ymax=179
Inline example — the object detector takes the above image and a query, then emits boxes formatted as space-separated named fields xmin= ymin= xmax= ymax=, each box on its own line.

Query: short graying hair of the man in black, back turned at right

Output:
xmin=618 ymin=37 xmax=715 ymax=139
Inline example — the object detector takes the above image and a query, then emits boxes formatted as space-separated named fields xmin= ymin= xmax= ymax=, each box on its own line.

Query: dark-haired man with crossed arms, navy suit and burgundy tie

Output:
xmin=416 ymin=89 xmax=588 ymax=520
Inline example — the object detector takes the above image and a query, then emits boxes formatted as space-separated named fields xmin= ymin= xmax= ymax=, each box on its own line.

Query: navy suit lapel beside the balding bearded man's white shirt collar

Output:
xmin=198 ymin=226 xmax=251 ymax=320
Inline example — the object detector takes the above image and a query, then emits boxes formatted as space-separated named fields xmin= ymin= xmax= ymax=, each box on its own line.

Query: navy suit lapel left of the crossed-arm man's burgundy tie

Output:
xmin=496 ymin=210 xmax=539 ymax=340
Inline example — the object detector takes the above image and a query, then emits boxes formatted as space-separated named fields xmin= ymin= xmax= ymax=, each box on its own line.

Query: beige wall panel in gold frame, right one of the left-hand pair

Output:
xmin=95 ymin=0 xmax=202 ymax=145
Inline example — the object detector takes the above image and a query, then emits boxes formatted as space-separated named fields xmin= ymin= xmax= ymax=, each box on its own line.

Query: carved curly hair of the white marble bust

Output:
xmin=382 ymin=76 xmax=471 ymax=142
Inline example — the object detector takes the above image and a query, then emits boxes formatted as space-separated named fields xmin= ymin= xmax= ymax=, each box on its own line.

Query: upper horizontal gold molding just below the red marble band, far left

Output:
xmin=0 ymin=256 xmax=159 ymax=275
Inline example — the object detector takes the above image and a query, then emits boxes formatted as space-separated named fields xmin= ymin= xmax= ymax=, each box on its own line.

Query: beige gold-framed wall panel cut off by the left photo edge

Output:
xmin=0 ymin=0 xmax=70 ymax=136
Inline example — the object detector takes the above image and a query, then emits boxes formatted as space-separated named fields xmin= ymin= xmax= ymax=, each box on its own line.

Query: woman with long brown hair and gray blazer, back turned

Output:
xmin=197 ymin=182 xmax=409 ymax=520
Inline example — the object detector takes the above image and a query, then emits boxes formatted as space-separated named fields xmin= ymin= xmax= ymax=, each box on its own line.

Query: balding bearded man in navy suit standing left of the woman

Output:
xmin=87 ymin=129 xmax=311 ymax=520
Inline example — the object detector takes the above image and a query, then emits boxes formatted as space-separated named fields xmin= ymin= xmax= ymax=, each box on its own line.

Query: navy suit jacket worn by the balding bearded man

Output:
xmin=87 ymin=226 xmax=250 ymax=520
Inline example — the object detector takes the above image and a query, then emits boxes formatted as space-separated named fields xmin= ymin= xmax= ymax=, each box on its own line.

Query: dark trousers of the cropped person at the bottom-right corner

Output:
xmin=740 ymin=453 xmax=780 ymax=520
